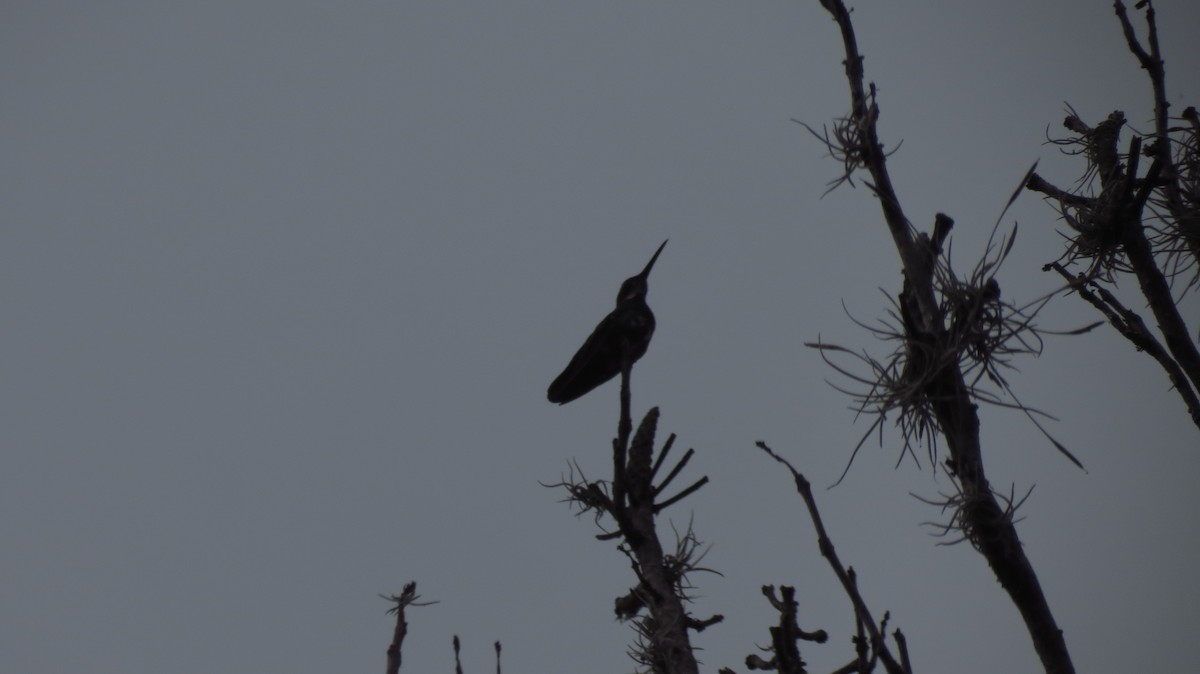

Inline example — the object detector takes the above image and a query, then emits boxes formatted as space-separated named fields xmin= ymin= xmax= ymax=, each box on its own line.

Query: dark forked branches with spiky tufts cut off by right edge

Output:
xmin=1027 ymin=0 xmax=1200 ymax=427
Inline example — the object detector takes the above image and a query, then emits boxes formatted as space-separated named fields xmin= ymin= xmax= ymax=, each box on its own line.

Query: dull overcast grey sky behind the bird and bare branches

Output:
xmin=0 ymin=0 xmax=1200 ymax=674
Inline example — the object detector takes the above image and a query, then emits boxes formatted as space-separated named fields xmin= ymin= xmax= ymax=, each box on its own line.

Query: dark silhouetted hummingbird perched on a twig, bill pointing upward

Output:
xmin=546 ymin=241 xmax=667 ymax=405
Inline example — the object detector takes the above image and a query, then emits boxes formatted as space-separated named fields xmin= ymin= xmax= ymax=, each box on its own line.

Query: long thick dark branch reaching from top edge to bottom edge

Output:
xmin=806 ymin=0 xmax=1074 ymax=674
